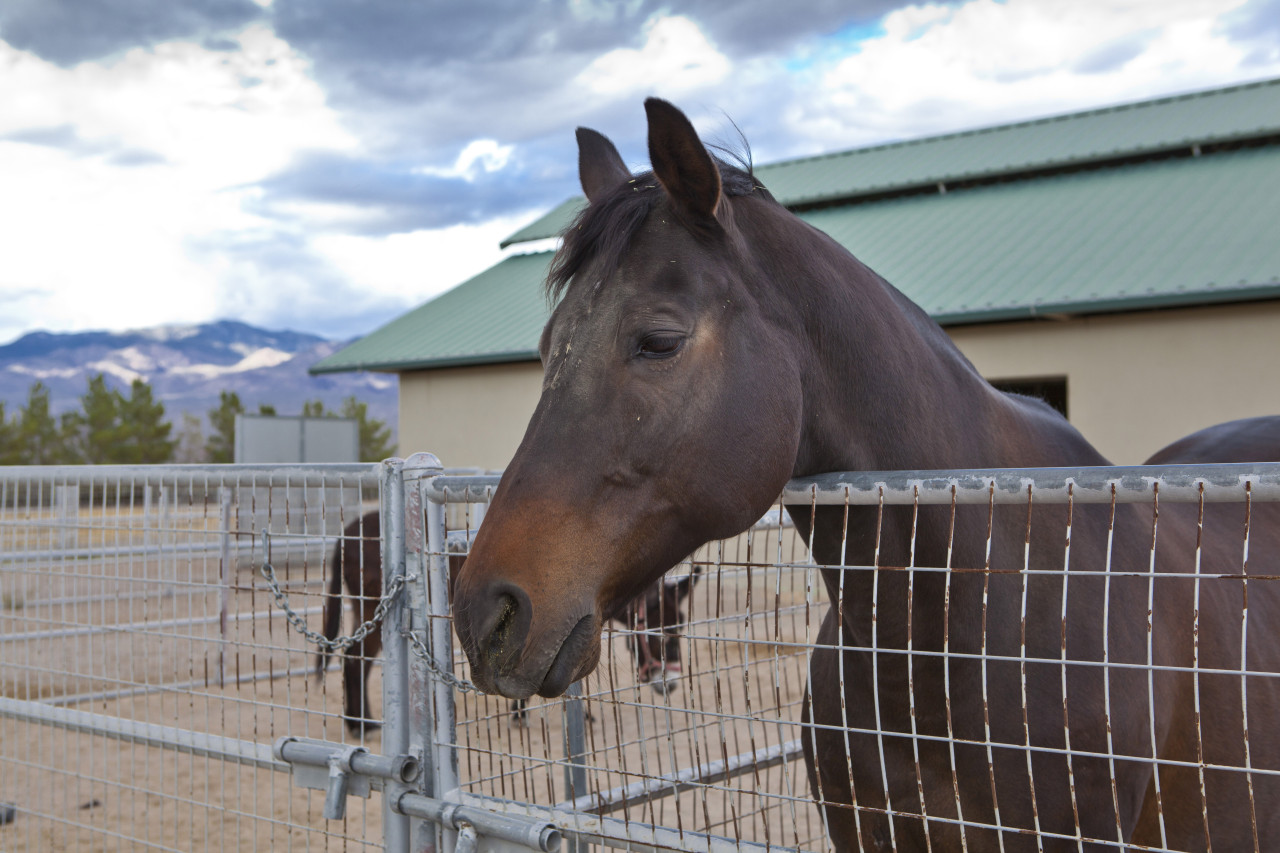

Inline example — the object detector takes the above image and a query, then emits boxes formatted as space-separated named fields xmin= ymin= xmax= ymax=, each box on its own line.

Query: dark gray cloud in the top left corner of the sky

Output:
xmin=0 ymin=0 xmax=264 ymax=67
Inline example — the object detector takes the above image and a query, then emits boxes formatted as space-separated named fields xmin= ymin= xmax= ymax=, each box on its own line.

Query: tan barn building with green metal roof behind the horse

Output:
xmin=312 ymin=79 xmax=1280 ymax=467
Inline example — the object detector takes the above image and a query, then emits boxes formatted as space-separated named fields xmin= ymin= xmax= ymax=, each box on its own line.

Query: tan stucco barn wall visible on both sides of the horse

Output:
xmin=399 ymin=301 xmax=1280 ymax=467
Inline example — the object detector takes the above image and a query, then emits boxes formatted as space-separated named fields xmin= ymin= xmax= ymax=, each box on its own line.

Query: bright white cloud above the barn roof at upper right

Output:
xmin=790 ymin=0 xmax=1280 ymax=149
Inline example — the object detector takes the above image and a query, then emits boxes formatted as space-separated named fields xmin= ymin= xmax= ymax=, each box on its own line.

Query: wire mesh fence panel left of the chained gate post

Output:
xmin=0 ymin=465 xmax=383 ymax=852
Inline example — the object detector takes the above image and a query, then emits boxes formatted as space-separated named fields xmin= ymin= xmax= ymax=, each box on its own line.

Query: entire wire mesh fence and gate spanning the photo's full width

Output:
xmin=0 ymin=455 xmax=1280 ymax=853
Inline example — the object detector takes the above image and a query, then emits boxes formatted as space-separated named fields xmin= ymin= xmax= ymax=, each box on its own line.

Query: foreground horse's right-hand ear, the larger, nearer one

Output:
xmin=644 ymin=97 xmax=721 ymax=220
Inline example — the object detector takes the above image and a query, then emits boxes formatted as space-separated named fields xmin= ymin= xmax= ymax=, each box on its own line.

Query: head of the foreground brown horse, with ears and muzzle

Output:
xmin=454 ymin=99 xmax=803 ymax=698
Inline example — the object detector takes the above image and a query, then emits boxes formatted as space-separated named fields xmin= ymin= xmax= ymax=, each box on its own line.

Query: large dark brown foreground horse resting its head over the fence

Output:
xmin=454 ymin=99 xmax=1280 ymax=853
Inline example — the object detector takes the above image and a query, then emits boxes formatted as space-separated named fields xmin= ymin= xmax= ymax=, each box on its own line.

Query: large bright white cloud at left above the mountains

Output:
xmin=0 ymin=27 xmax=355 ymax=341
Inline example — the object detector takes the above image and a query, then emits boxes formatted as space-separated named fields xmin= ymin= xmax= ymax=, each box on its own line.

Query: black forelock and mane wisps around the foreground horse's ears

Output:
xmin=545 ymin=147 xmax=773 ymax=302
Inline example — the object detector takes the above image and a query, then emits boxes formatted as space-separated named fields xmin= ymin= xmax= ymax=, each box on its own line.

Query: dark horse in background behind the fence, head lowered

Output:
xmin=316 ymin=511 xmax=703 ymax=735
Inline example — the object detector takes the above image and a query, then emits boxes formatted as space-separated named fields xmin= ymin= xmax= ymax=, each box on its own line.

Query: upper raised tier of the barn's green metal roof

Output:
xmin=502 ymin=79 xmax=1280 ymax=246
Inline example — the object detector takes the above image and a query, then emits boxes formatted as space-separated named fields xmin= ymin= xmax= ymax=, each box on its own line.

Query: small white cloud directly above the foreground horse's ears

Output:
xmin=575 ymin=15 xmax=731 ymax=97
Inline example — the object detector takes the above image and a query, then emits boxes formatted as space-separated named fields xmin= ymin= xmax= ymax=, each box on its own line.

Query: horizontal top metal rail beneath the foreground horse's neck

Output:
xmin=428 ymin=462 xmax=1280 ymax=506
